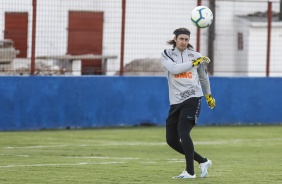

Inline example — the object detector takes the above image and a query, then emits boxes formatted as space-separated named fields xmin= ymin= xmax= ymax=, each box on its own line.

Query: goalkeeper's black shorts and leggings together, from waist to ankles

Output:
xmin=166 ymin=98 xmax=206 ymax=175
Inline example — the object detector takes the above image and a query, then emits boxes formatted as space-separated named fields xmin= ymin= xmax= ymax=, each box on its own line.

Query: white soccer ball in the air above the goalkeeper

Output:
xmin=191 ymin=6 xmax=213 ymax=28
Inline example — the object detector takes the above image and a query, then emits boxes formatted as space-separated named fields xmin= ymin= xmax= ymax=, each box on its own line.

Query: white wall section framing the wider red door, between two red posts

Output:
xmin=37 ymin=0 xmax=121 ymax=55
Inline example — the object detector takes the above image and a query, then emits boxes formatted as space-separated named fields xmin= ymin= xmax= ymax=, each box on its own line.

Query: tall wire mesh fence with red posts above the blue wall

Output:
xmin=0 ymin=0 xmax=282 ymax=76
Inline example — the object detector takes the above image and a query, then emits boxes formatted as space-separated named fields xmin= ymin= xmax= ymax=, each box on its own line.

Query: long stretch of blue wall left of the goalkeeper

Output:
xmin=0 ymin=76 xmax=168 ymax=130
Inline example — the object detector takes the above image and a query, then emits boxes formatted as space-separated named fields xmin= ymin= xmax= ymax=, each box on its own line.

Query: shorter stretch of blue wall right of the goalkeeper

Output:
xmin=201 ymin=77 xmax=282 ymax=124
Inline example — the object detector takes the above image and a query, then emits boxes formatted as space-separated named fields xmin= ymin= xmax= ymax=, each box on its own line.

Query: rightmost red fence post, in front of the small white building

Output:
xmin=266 ymin=1 xmax=272 ymax=77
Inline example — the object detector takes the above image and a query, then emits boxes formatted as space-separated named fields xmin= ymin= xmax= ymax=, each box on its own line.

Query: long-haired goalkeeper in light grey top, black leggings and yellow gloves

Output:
xmin=161 ymin=28 xmax=216 ymax=178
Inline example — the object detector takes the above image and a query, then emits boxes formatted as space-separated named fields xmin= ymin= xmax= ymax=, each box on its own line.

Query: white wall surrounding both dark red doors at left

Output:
xmin=0 ymin=0 xmax=121 ymax=57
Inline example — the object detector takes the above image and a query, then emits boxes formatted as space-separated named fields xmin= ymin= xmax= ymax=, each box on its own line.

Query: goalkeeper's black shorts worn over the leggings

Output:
xmin=166 ymin=97 xmax=201 ymax=124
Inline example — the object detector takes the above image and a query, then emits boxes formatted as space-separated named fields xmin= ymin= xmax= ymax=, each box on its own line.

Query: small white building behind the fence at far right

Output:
xmin=234 ymin=16 xmax=282 ymax=76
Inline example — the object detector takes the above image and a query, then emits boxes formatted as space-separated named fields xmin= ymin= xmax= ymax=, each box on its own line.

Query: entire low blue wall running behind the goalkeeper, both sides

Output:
xmin=0 ymin=76 xmax=282 ymax=131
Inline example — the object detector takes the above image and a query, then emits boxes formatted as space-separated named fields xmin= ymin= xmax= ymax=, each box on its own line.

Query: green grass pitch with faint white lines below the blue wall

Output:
xmin=0 ymin=126 xmax=282 ymax=184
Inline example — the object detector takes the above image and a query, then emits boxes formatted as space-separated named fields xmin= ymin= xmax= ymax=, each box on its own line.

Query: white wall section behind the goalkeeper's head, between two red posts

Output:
xmin=125 ymin=0 xmax=196 ymax=63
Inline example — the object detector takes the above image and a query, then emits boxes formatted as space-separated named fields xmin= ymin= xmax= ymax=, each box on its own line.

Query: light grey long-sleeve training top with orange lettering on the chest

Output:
xmin=161 ymin=48 xmax=211 ymax=105
